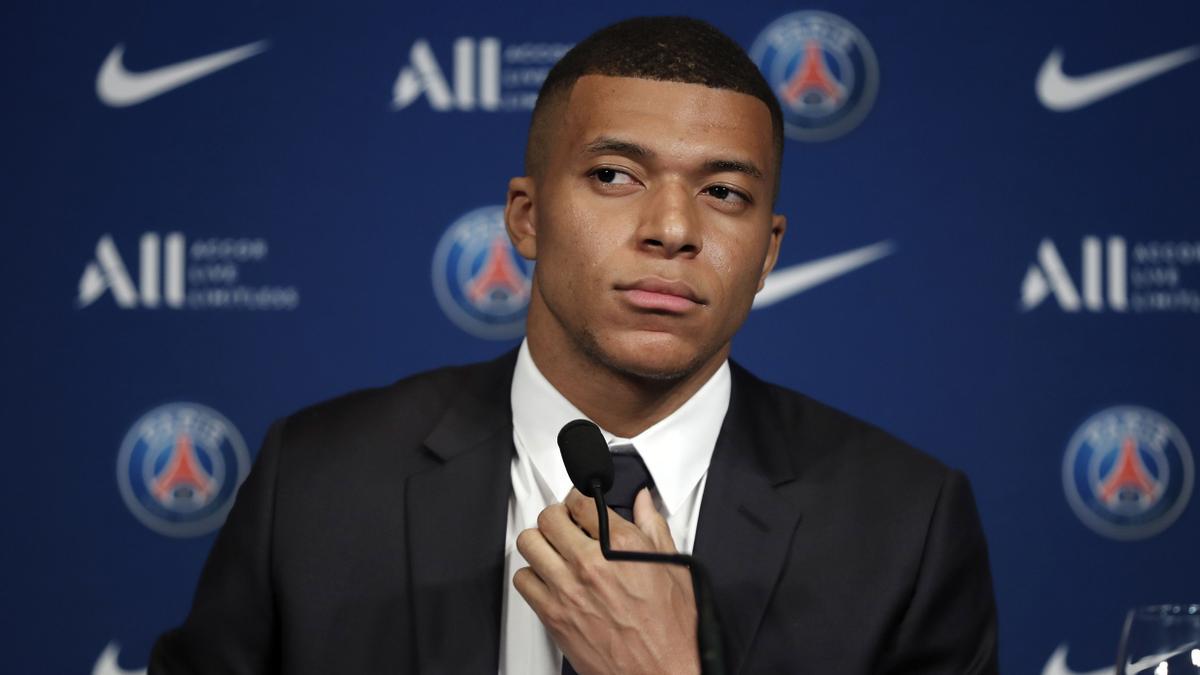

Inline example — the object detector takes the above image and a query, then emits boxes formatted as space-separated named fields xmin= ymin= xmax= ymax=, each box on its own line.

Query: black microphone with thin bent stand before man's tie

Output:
xmin=558 ymin=419 xmax=725 ymax=675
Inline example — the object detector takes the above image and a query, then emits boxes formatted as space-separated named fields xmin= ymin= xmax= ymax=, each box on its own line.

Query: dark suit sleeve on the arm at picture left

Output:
xmin=149 ymin=420 xmax=284 ymax=675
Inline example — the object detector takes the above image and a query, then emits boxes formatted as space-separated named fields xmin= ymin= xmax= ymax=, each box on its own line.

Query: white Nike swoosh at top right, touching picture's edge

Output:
xmin=1036 ymin=46 xmax=1200 ymax=113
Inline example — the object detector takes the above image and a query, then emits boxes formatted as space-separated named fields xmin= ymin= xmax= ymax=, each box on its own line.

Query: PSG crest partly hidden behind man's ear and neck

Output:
xmin=433 ymin=207 xmax=533 ymax=340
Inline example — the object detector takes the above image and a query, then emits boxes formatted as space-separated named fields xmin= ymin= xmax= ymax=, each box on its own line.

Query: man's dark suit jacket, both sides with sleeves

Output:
xmin=150 ymin=353 xmax=996 ymax=675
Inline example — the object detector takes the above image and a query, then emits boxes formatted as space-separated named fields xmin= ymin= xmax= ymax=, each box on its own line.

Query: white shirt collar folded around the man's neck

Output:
xmin=511 ymin=341 xmax=731 ymax=516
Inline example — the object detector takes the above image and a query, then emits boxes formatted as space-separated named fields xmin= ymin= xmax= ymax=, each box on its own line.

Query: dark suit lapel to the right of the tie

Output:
xmin=692 ymin=364 xmax=800 ymax=673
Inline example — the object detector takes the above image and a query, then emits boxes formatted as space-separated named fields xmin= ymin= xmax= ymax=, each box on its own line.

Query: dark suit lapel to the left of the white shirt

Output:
xmin=406 ymin=353 xmax=515 ymax=674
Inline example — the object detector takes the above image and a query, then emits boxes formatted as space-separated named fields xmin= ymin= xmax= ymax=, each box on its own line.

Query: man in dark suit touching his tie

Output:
xmin=150 ymin=18 xmax=996 ymax=675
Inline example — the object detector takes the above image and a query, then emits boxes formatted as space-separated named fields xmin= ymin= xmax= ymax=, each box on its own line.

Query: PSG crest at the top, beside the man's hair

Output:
xmin=750 ymin=11 xmax=880 ymax=141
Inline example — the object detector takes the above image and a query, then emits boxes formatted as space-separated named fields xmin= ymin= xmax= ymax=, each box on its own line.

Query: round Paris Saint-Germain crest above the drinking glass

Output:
xmin=1062 ymin=406 xmax=1194 ymax=540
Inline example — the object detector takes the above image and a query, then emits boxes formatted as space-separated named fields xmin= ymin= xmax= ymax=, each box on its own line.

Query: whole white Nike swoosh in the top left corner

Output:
xmin=96 ymin=40 xmax=266 ymax=108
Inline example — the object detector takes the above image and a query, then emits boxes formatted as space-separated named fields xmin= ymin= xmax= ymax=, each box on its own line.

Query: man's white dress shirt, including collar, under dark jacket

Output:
xmin=500 ymin=342 xmax=730 ymax=675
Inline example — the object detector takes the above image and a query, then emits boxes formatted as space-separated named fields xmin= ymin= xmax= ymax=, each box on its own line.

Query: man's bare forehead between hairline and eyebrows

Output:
xmin=559 ymin=74 xmax=773 ymax=163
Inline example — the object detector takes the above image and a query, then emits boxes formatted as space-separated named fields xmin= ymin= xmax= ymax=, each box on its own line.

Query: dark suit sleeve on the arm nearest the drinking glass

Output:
xmin=883 ymin=471 xmax=998 ymax=675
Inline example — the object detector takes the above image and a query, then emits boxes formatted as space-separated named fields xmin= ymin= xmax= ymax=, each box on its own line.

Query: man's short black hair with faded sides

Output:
xmin=524 ymin=17 xmax=784 ymax=193
